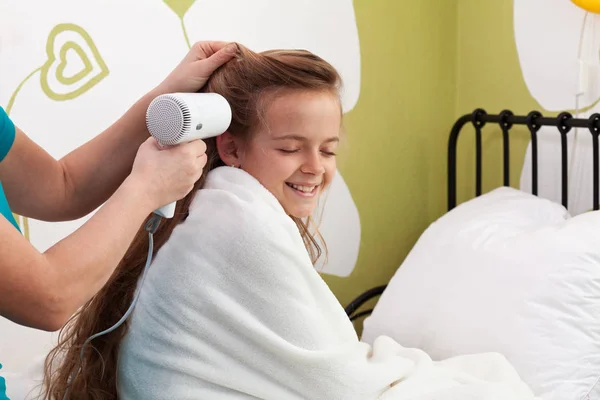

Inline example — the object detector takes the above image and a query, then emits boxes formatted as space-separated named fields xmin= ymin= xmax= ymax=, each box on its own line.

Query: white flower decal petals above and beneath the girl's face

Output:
xmin=183 ymin=0 xmax=360 ymax=276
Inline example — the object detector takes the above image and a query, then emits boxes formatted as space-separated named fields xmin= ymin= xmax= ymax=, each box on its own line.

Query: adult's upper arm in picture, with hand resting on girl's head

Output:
xmin=0 ymin=42 xmax=236 ymax=221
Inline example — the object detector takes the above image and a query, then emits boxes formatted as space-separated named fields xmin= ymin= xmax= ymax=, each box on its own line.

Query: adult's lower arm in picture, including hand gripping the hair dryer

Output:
xmin=0 ymin=139 xmax=206 ymax=331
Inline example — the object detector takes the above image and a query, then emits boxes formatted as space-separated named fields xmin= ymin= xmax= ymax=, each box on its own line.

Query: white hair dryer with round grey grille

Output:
xmin=146 ymin=93 xmax=231 ymax=218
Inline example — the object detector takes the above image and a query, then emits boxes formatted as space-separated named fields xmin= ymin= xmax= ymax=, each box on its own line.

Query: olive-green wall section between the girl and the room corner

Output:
xmin=324 ymin=0 xmax=457 ymax=306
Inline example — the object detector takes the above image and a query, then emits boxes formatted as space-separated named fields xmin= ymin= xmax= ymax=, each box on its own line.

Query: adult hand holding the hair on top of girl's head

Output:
xmin=155 ymin=42 xmax=238 ymax=95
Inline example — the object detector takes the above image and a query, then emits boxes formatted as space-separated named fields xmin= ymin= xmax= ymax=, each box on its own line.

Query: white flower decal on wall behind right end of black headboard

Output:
xmin=514 ymin=0 xmax=600 ymax=214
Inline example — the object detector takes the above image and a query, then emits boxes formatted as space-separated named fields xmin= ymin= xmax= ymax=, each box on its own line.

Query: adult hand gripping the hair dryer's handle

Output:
xmin=127 ymin=137 xmax=207 ymax=210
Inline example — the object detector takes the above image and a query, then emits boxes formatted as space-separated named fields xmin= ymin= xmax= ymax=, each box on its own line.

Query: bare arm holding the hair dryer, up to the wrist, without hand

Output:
xmin=0 ymin=175 xmax=151 ymax=331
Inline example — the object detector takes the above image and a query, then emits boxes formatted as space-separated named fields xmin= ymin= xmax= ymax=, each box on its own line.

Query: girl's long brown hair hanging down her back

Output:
xmin=43 ymin=45 xmax=341 ymax=400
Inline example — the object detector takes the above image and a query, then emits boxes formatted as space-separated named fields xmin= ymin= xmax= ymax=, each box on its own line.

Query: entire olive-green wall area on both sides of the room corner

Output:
xmin=324 ymin=0 xmax=548 ymax=318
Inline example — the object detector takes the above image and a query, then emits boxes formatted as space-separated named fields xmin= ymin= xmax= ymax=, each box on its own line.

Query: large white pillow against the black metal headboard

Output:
xmin=362 ymin=187 xmax=600 ymax=400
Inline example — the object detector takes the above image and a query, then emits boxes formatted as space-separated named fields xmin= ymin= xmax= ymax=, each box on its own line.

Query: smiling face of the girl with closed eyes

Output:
xmin=224 ymin=91 xmax=342 ymax=218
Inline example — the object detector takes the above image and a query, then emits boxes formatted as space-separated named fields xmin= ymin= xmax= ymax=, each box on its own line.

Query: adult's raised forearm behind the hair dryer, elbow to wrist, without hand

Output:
xmin=59 ymin=92 xmax=156 ymax=219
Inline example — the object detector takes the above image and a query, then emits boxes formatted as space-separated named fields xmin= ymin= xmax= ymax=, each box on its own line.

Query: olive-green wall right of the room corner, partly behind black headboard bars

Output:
xmin=456 ymin=0 xmax=550 ymax=201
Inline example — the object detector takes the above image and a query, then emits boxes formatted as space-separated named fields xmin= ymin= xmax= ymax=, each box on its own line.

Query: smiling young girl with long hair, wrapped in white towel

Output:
xmin=46 ymin=46 xmax=533 ymax=400
